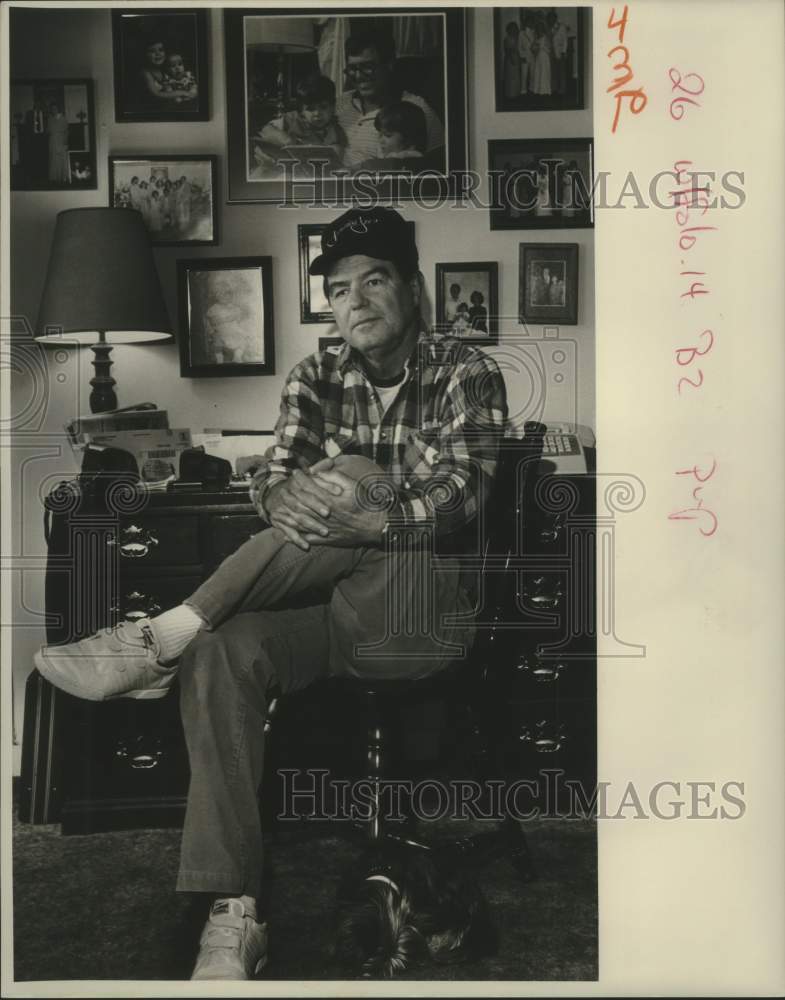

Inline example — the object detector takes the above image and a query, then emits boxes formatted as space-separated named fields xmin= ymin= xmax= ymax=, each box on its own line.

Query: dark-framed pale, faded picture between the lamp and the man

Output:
xmin=177 ymin=257 xmax=275 ymax=378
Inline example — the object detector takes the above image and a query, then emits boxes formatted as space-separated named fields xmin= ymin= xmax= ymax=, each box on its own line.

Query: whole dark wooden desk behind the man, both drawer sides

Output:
xmin=19 ymin=458 xmax=596 ymax=833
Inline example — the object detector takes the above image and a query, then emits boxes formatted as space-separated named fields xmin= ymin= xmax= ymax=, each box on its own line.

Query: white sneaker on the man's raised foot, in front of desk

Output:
xmin=33 ymin=619 xmax=177 ymax=701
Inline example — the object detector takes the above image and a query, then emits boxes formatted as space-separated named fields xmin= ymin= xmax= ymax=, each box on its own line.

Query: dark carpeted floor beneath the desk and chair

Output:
xmin=14 ymin=804 xmax=597 ymax=981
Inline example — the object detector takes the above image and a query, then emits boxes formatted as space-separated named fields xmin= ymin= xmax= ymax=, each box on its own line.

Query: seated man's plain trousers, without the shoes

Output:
xmin=177 ymin=496 xmax=474 ymax=896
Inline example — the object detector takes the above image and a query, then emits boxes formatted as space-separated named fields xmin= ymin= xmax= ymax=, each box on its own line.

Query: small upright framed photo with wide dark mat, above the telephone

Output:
xmin=518 ymin=243 xmax=578 ymax=326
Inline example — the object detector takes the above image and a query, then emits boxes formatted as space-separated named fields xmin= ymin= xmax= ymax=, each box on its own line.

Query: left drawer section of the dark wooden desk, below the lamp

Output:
xmin=19 ymin=482 xmax=265 ymax=833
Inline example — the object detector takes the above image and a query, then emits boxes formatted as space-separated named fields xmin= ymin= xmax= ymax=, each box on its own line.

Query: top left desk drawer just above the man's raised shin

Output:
xmin=110 ymin=514 xmax=202 ymax=570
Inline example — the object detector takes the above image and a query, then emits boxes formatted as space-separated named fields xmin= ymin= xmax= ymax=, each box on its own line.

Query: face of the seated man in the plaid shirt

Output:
xmin=327 ymin=255 xmax=420 ymax=354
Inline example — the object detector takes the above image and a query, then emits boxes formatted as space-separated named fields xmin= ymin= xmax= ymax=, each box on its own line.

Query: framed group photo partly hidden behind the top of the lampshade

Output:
xmin=109 ymin=154 xmax=218 ymax=246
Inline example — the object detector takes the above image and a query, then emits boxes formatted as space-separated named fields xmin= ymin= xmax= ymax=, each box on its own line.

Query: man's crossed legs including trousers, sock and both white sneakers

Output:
xmin=36 ymin=457 xmax=470 ymax=979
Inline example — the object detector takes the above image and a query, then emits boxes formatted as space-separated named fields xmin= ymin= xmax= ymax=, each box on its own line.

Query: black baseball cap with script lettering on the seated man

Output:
xmin=308 ymin=207 xmax=419 ymax=274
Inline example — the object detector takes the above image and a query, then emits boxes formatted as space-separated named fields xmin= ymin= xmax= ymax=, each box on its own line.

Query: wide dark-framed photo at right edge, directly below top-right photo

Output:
xmin=488 ymin=138 xmax=594 ymax=229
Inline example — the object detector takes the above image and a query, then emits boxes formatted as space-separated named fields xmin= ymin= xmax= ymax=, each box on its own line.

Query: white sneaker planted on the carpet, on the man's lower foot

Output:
xmin=191 ymin=899 xmax=267 ymax=980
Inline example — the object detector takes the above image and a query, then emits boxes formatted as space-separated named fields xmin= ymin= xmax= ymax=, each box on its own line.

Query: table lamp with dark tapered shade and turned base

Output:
xmin=35 ymin=208 xmax=173 ymax=413
